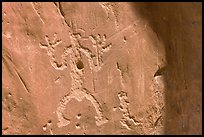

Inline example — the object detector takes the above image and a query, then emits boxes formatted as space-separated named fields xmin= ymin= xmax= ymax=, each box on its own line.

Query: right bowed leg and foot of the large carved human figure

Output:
xmin=84 ymin=91 xmax=108 ymax=126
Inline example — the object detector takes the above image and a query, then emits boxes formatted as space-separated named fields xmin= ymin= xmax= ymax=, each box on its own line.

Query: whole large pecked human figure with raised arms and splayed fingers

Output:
xmin=40 ymin=30 xmax=111 ymax=127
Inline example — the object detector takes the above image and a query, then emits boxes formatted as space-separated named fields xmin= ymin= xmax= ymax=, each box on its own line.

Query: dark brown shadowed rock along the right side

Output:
xmin=130 ymin=2 xmax=202 ymax=134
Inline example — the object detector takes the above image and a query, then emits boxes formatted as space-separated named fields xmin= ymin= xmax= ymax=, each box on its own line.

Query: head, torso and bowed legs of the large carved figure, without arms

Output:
xmin=54 ymin=33 xmax=108 ymax=127
